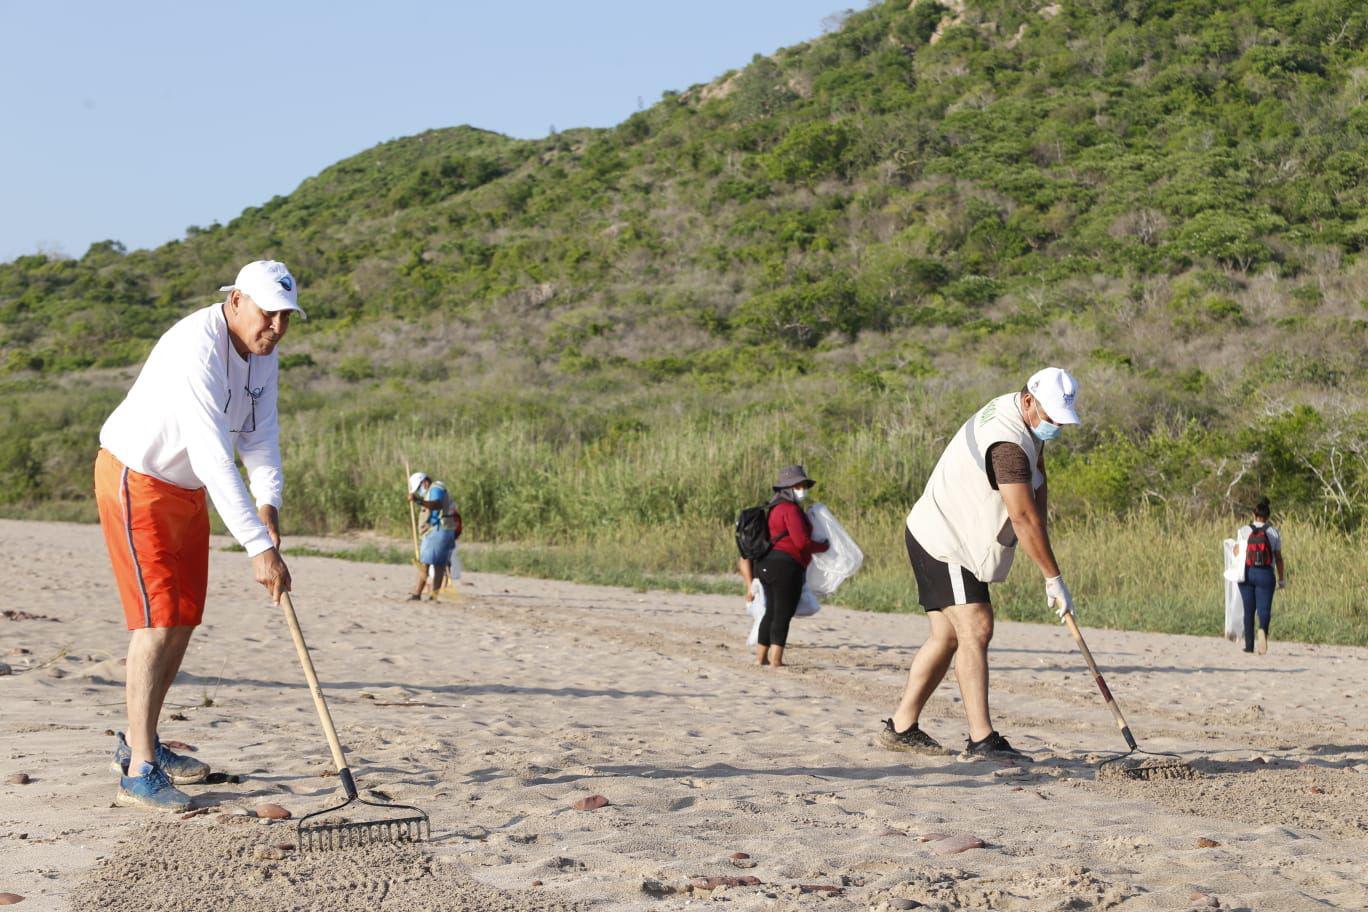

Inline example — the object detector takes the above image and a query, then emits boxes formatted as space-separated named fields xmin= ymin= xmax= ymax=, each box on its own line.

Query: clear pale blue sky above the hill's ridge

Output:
xmin=0 ymin=0 xmax=850 ymax=261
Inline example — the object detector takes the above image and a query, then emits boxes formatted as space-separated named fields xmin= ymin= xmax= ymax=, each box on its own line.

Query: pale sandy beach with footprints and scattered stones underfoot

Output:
xmin=0 ymin=521 xmax=1368 ymax=912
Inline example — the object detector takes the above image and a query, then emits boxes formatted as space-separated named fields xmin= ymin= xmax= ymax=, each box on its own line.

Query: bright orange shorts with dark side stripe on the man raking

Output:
xmin=94 ymin=450 xmax=209 ymax=630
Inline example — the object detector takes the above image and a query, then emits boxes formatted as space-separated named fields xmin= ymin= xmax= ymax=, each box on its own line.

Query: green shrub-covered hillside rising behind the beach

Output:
xmin=0 ymin=0 xmax=1368 ymax=642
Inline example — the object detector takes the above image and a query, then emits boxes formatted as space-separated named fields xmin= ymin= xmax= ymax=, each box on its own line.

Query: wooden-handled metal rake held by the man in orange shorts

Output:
xmin=280 ymin=592 xmax=432 ymax=852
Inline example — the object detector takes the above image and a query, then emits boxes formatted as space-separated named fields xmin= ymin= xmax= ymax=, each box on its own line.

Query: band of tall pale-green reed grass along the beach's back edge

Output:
xmin=274 ymin=402 xmax=1368 ymax=644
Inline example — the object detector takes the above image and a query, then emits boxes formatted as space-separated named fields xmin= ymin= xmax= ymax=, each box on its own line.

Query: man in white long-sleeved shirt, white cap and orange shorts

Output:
xmin=94 ymin=260 xmax=304 ymax=811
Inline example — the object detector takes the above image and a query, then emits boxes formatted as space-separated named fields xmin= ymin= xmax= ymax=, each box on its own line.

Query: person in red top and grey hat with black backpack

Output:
xmin=752 ymin=465 xmax=830 ymax=669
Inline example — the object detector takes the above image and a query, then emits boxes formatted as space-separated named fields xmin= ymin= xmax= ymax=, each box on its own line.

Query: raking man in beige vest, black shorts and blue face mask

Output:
xmin=880 ymin=368 xmax=1078 ymax=757
